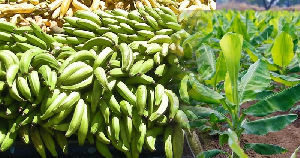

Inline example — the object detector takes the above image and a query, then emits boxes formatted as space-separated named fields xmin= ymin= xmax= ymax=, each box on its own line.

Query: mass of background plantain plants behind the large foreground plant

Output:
xmin=179 ymin=10 xmax=300 ymax=89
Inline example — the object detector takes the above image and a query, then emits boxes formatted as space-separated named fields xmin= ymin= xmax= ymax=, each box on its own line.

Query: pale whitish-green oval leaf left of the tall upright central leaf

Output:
xmin=195 ymin=43 xmax=216 ymax=80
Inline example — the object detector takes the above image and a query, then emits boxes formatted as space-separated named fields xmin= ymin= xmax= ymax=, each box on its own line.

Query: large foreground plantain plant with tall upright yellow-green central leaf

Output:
xmin=179 ymin=32 xmax=300 ymax=158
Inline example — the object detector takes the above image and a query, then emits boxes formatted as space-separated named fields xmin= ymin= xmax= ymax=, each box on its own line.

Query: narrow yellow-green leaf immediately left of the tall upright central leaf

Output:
xmin=205 ymin=53 xmax=227 ymax=86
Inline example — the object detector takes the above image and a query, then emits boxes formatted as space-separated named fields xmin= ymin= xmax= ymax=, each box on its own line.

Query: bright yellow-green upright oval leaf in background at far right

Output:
xmin=271 ymin=32 xmax=294 ymax=67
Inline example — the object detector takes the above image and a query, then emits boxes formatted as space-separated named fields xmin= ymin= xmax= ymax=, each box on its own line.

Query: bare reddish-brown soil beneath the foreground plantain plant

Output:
xmin=183 ymin=102 xmax=300 ymax=158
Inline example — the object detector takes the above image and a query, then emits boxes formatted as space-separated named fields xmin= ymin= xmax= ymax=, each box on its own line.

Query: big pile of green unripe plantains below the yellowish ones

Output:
xmin=0 ymin=6 xmax=187 ymax=158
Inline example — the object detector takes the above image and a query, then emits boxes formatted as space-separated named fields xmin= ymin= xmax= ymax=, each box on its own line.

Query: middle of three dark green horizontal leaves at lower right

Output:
xmin=242 ymin=114 xmax=298 ymax=135
